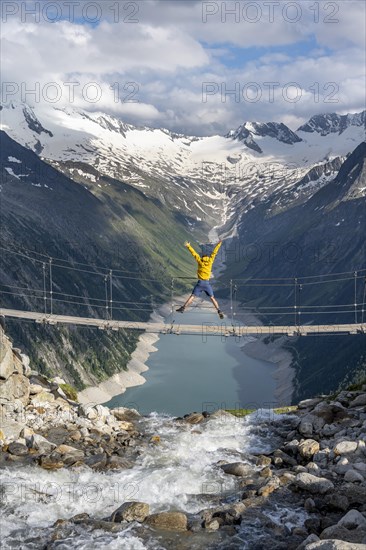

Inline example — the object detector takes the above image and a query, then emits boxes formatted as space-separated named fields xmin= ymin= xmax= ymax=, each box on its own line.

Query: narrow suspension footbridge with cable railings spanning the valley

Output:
xmin=0 ymin=246 xmax=366 ymax=337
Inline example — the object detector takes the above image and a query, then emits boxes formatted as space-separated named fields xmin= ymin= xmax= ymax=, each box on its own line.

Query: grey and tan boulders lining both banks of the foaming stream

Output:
xmin=0 ymin=326 xmax=366 ymax=550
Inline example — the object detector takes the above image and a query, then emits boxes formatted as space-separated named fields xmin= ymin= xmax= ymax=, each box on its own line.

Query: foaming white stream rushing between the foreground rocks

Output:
xmin=0 ymin=411 xmax=306 ymax=550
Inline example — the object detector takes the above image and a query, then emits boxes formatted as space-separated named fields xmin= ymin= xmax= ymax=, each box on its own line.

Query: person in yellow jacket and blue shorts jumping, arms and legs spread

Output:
xmin=176 ymin=239 xmax=224 ymax=319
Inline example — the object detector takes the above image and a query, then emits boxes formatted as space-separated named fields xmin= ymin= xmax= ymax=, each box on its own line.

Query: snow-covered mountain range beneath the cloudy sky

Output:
xmin=0 ymin=104 xmax=365 ymax=225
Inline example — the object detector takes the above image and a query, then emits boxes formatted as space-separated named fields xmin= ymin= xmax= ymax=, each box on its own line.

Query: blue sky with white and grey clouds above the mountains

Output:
xmin=1 ymin=0 xmax=366 ymax=135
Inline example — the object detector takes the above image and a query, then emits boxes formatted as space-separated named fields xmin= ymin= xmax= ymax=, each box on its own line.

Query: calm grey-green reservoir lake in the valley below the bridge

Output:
xmin=107 ymin=302 xmax=276 ymax=416
